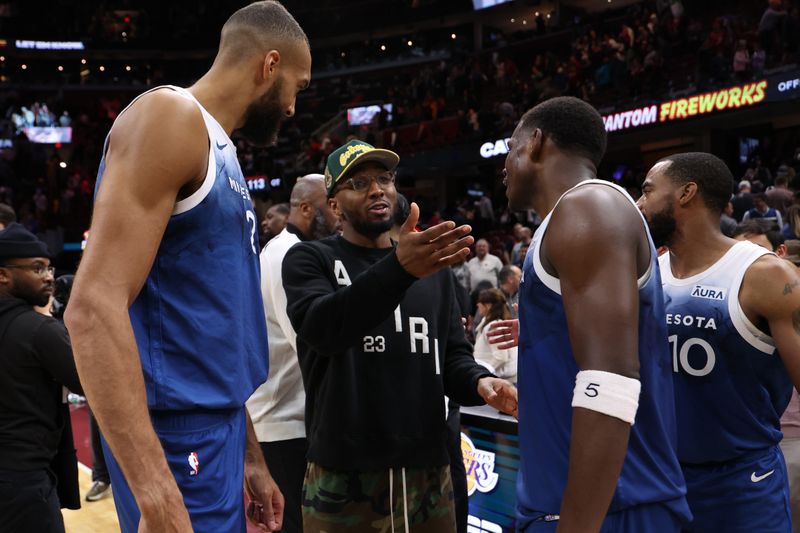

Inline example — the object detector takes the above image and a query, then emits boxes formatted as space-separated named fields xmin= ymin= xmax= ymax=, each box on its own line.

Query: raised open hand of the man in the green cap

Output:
xmin=395 ymin=203 xmax=475 ymax=278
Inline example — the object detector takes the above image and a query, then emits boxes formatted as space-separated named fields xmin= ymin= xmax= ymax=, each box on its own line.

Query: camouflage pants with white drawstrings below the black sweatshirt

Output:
xmin=303 ymin=463 xmax=456 ymax=533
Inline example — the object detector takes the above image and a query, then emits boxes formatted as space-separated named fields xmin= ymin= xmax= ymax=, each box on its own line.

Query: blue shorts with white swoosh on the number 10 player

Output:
xmin=682 ymin=446 xmax=792 ymax=533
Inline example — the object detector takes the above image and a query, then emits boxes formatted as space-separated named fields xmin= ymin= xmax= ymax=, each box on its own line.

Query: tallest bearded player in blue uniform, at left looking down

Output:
xmin=66 ymin=1 xmax=311 ymax=532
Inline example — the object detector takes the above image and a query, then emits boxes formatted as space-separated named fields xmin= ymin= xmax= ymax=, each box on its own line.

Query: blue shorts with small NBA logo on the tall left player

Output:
xmin=103 ymin=407 xmax=247 ymax=533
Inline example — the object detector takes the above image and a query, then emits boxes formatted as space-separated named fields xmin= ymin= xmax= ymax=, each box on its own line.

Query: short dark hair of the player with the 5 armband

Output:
xmin=520 ymin=96 xmax=607 ymax=167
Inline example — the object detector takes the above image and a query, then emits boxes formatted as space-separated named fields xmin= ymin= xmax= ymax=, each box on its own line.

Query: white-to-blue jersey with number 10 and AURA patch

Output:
xmin=660 ymin=241 xmax=792 ymax=464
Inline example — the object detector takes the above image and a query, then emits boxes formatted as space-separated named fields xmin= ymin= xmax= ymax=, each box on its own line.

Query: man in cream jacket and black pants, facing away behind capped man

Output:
xmin=247 ymin=174 xmax=339 ymax=533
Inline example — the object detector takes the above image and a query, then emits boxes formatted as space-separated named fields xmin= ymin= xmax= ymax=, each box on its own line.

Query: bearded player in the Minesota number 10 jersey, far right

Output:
xmin=639 ymin=153 xmax=800 ymax=533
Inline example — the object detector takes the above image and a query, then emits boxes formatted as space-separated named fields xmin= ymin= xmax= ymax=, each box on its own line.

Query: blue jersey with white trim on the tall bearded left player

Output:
xmin=90 ymin=86 xmax=268 ymax=410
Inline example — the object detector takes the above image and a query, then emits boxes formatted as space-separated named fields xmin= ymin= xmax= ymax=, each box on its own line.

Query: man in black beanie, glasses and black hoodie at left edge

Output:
xmin=0 ymin=223 xmax=83 ymax=533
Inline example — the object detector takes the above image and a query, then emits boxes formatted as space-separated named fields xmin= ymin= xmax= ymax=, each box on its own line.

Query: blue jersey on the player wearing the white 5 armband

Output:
xmin=517 ymin=180 xmax=690 ymax=529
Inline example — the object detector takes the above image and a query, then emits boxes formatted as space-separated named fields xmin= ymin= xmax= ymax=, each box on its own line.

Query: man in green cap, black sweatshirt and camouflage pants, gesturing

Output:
xmin=283 ymin=141 xmax=517 ymax=533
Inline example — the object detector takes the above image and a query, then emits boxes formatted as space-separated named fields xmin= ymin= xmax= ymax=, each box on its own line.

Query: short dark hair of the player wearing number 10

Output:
xmin=659 ymin=152 xmax=733 ymax=213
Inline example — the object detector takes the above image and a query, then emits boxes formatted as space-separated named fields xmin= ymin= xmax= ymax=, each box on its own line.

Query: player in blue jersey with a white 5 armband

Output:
xmin=505 ymin=97 xmax=689 ymax=533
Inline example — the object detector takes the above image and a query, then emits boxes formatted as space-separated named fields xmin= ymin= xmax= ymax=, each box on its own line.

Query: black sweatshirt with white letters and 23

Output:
xmin=283 ymin=236 xmax=492 ymax=470
